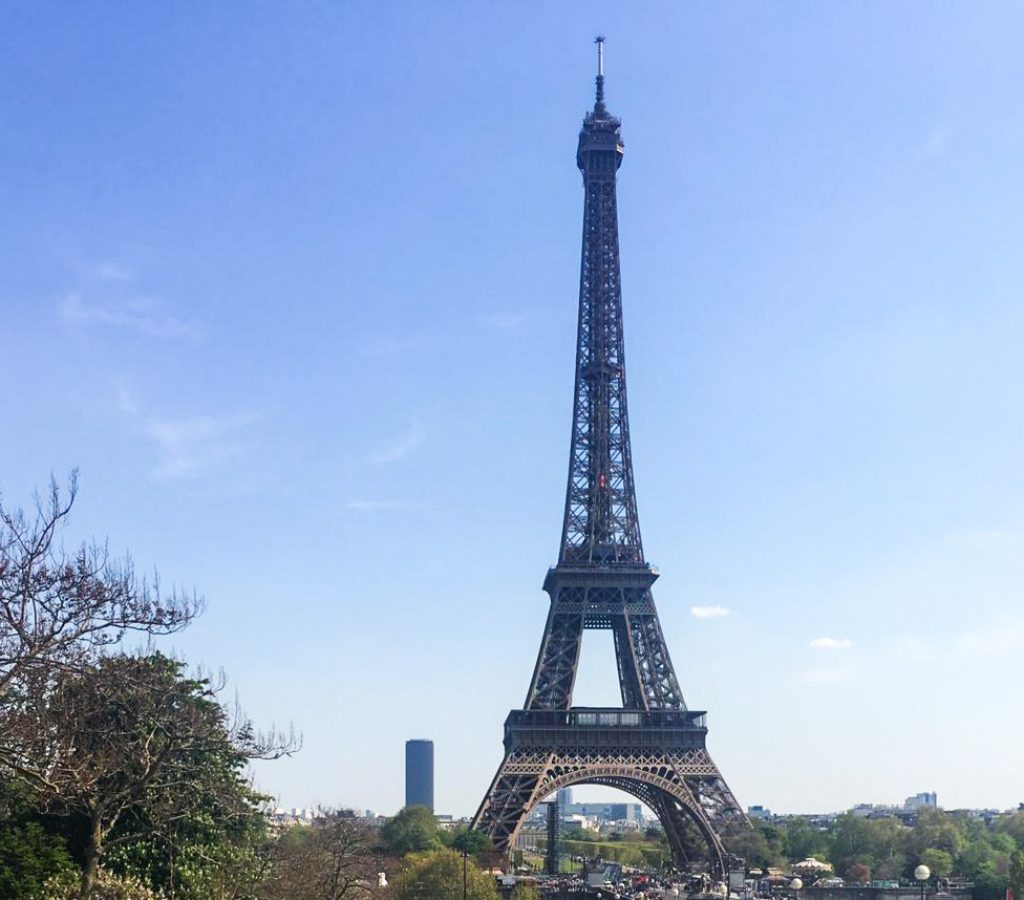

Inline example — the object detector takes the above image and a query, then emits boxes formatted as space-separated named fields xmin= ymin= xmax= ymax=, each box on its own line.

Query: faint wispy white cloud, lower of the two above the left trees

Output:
xmin=145 ymin=413 xmax=262 ymax=478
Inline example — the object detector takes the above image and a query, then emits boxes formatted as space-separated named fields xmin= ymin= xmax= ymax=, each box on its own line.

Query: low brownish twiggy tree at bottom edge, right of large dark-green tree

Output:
xmin=257 ymin=813 xmax=381 ymax=900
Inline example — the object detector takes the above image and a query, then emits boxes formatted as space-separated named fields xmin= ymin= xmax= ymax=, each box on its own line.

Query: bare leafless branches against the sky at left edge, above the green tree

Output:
xmin=0 ymin=472 xmax=202 ymax=692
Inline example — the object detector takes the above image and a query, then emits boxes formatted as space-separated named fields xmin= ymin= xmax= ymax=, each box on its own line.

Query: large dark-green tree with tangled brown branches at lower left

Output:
xmin=0 ymin=654 xmax=295 ymax=900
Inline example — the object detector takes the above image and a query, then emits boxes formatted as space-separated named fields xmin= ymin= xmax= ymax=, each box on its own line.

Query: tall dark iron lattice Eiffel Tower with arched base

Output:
xmin=473 ymin=38 xmax=750 ymax=874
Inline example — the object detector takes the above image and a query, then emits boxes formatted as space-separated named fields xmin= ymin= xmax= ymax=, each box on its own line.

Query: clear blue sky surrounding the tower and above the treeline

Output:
xmin=0 ymin=2 xmax=1024 ymax=814
